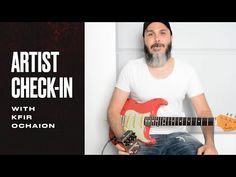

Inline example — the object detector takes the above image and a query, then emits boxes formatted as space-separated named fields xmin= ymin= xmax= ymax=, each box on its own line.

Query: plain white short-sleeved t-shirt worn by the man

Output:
xmin=116 ymin=58 xmax=203 ymax=134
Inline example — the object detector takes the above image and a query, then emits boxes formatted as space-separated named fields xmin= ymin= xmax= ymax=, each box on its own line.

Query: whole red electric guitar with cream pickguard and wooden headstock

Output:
xmin=109 ymin=98 xmax=236 ymax=144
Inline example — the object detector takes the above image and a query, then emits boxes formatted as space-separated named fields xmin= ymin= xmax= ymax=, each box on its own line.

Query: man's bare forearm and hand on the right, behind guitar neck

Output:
xmin=191 ymin=94 xmax=217 ymax=154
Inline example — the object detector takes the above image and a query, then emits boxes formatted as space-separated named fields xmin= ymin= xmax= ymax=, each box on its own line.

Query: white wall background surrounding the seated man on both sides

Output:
xmin=85 ymin=23 xmax=236 ymax=154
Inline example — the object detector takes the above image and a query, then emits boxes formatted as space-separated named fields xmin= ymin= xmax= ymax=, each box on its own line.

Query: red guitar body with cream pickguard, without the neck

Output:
xmin=109 ymin=98 xmax=168 ymax=144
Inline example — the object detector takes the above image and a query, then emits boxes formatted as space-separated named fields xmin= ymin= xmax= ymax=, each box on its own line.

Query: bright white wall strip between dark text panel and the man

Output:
xmin=85 ymin=23 xmax=116 ymax=154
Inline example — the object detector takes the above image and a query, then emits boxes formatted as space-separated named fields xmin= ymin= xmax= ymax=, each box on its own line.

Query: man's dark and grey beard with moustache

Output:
xmin=144 ymin=42 xmax=172 ymax=67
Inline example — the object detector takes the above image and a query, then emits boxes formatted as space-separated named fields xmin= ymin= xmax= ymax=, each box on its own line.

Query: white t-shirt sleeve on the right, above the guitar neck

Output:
xmin=187 ymin=70 xmax=204 ymax=98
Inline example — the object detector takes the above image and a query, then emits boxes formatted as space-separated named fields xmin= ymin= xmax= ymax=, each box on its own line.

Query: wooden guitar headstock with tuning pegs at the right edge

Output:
xmin=216 ymin=114 xmax=236 ymax=131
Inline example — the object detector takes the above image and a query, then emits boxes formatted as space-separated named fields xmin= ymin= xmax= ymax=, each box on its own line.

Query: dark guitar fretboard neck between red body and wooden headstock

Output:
xmin=144 ymin=117 xmax=215 ymax=126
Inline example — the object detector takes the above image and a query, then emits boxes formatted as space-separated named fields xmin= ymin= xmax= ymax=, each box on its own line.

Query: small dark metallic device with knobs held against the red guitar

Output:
xmin=117 ymin=130 xmax=140 ymax=154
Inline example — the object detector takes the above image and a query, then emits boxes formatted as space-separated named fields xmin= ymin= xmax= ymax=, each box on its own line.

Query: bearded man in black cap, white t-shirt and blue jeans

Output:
xmin=108 ymin=21 xmax=217 ymax=155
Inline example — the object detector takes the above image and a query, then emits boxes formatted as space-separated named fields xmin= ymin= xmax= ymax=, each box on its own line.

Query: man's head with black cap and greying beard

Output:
xmin=143 ymin=22 xmax=172 ymax=67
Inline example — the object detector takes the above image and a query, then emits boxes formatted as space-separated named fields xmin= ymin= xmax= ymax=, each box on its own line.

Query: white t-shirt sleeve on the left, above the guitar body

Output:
xmin=116 ymin=63 xmax=131 ymax=92
